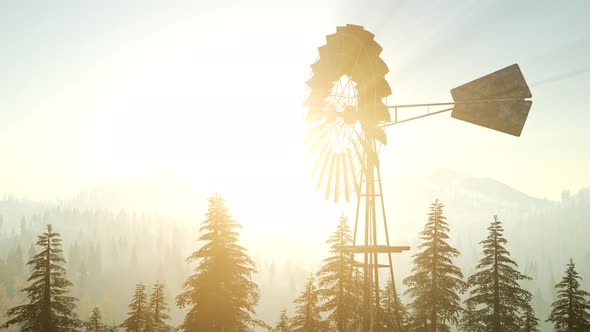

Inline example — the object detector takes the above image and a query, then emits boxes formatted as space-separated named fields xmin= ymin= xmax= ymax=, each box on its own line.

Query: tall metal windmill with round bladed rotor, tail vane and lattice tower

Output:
xmin=304 ymin=25 xmax=532 ymax=331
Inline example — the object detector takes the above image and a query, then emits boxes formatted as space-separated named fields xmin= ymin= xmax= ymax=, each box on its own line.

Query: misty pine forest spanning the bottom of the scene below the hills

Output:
xmin=0 ymin=183 xmax=590 ymax=332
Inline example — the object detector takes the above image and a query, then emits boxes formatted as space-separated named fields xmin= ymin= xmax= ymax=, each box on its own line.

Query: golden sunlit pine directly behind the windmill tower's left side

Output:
xmin=317 ymin=215 xmax=362 ymax=331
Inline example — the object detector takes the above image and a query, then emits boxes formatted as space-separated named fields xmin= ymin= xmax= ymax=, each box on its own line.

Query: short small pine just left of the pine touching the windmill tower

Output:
xmin=290 ymin=276 xmax=326 ymax=332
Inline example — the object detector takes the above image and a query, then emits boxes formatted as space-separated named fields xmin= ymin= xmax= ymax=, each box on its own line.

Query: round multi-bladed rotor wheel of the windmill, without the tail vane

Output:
xmin=305 ymin=25 xmax=391 ymax=202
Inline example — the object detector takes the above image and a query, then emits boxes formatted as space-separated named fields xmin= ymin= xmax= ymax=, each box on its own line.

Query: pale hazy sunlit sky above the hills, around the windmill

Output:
xmin=0 ymin=0 xmax=590 ymax=204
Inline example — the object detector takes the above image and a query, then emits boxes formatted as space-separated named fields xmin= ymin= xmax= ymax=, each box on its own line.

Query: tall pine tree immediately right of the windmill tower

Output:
xmin=404 ymin=199 xmax=465 ymax=331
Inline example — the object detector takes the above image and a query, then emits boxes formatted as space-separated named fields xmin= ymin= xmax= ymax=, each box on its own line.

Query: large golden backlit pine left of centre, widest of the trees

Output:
xmin=176 ymin=194 xmax=260 ymax=331
